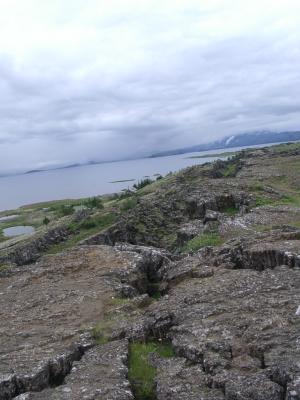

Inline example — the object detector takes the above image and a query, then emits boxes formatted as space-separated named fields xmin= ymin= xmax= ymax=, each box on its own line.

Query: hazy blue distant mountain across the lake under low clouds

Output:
xmin=150 ymin=131 xmax=300 ymax=157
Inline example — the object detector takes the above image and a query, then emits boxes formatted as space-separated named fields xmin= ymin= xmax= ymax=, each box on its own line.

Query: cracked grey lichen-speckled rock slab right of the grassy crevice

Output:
xmin=115 ymin=232 xmax=300 ymax=400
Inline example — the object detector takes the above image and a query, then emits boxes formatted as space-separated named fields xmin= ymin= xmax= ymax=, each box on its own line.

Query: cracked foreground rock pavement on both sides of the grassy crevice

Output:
xmin=0 ymin=231 xmax=300 ymax=400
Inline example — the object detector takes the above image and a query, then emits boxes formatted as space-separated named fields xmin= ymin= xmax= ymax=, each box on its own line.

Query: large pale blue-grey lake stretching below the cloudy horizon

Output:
xmin=0 ymin=145 xmax=282 ymax=211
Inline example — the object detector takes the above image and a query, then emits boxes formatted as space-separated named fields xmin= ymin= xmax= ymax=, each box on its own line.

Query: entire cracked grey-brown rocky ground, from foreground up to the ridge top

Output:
xmin=0 ymin=145 xmax=300 ymax=400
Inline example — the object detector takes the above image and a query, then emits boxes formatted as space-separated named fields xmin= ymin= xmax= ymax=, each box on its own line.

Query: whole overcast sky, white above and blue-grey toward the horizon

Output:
xmin=0 ymin=0 xmax=300 ymax=173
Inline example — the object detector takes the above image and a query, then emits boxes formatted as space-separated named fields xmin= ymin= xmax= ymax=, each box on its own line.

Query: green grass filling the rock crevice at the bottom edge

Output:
xmin=128 ymin=342 xmax=174 ymax=400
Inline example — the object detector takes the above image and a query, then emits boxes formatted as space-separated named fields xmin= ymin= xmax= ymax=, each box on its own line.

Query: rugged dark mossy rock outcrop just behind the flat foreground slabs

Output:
xmin=81 ymin=190 xmax=254 ymax=251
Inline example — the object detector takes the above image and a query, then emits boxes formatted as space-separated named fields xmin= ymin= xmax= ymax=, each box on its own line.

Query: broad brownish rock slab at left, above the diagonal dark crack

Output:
xmin=0 ymin=246 xmax=159 ymax=400
